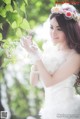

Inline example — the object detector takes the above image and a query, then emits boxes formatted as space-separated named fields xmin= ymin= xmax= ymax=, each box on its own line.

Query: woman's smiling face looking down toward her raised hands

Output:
xmin=50 ymin=18 xmax=66 ymax=44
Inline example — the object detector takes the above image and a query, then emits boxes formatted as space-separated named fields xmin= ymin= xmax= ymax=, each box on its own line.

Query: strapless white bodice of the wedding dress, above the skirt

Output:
xmin=42 ymin=46 xmax=77 ymax=103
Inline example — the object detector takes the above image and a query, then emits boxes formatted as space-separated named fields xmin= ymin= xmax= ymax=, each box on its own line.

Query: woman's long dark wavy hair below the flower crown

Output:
xmin=50 ymin=10 xmax=80 ymax=89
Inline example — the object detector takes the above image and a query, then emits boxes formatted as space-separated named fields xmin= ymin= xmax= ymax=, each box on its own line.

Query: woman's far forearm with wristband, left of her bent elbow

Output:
xmin=30 ymin=65 xmax=39 ymax=86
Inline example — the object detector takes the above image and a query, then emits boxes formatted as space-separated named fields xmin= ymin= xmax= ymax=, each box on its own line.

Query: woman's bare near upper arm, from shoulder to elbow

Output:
xmin=48 ymin=49 xmax=80 ymax=84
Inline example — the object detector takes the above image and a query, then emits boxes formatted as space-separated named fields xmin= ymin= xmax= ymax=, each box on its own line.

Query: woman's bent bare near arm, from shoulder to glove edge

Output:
xmin=36 ymin=54 xmax=80 ymax=87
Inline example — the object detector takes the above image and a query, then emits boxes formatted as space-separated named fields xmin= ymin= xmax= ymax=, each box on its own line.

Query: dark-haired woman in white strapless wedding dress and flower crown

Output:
xmin=23 ymin=4 xmax=80 ymax=119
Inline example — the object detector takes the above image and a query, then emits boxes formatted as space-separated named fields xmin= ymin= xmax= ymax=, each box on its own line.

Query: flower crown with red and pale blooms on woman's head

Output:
xmin=51 ymin=6 xmax=80 ymax=21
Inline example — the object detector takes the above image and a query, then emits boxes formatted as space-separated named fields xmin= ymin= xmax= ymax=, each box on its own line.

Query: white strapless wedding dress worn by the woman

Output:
xmin=39 ymin=45 xmax=80 ymax=119
